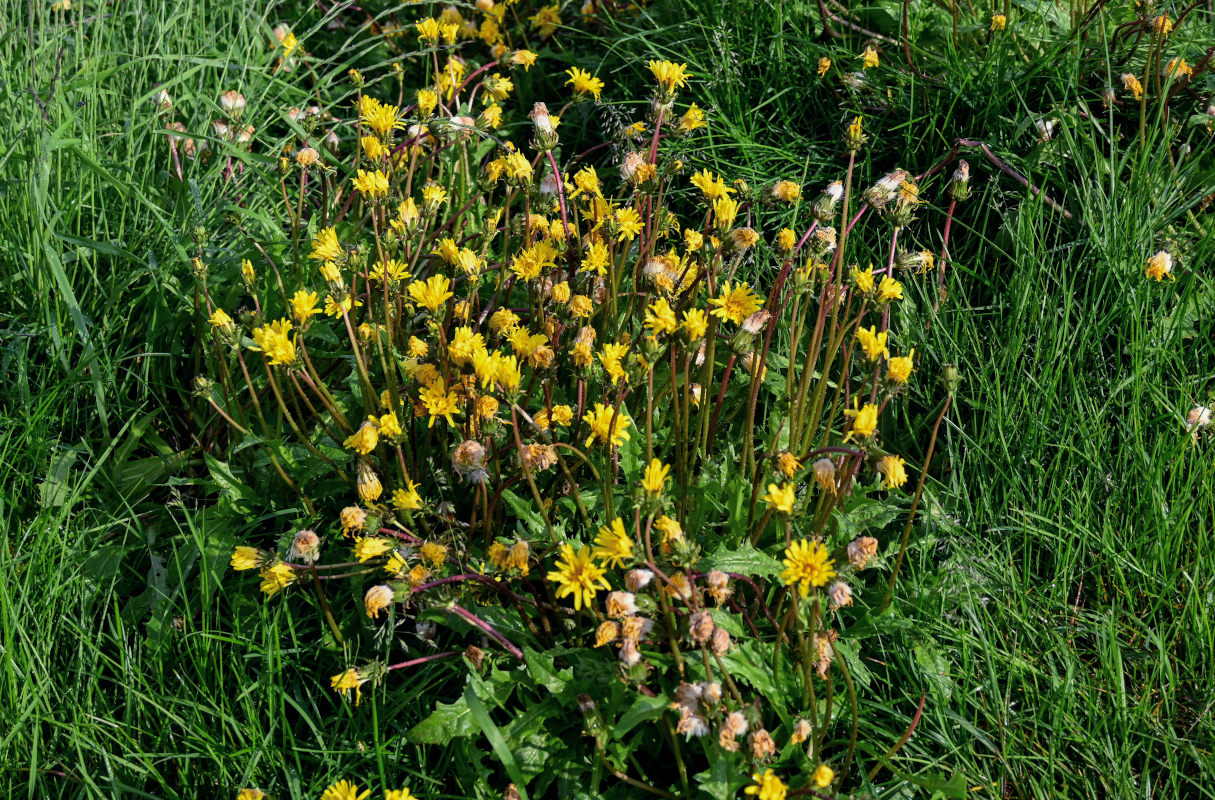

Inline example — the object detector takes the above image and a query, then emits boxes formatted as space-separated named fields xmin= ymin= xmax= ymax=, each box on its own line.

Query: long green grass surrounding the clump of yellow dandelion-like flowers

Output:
xmin=0 ymin=0 xmax=1215 ymax=798
